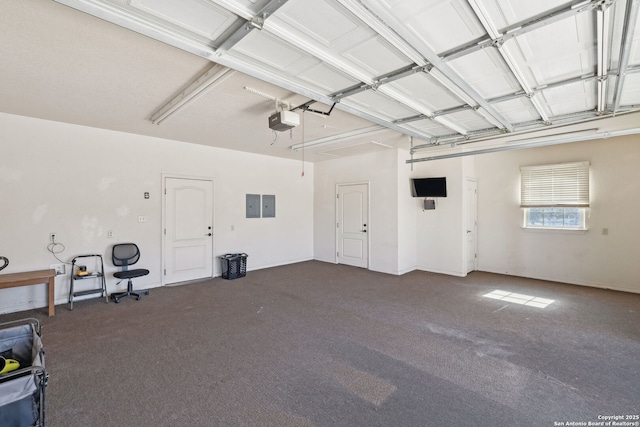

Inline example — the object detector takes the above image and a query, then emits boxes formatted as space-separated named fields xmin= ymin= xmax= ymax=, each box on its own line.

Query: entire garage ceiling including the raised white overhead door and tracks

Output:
xmin=0 ymin=0 xmax=640 ymax=161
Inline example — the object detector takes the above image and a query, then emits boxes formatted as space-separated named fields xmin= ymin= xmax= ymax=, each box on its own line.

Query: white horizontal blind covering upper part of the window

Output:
xmin=520 ymin=162 xmax=589 ymax=208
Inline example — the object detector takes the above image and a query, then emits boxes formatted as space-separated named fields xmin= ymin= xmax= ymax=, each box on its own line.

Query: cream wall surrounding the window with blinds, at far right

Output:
xmin=477 ymin=136 xmax=640 ymax=292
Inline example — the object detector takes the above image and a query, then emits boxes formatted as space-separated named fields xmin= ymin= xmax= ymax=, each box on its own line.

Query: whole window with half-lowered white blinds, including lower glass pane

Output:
xmin=520 ymin=162 xmax=589 ymax=230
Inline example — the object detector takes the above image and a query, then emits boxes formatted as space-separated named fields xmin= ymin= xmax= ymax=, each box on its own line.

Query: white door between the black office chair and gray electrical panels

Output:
xmin=164 ymin=177 xmax=213 ymax=284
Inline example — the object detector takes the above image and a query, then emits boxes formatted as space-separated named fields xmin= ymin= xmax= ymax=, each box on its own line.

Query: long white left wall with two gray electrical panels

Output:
xmin=0 ymin=114 xmax=314 ymax=313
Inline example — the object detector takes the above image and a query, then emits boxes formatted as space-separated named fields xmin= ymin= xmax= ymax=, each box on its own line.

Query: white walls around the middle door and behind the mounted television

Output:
xmin=314 ymin=149 xmax=475 ymax=276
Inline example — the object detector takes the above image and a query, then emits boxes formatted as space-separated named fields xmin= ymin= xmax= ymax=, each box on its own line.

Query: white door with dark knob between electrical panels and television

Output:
xmin=336 ymin=184 xmax=369 ymax=268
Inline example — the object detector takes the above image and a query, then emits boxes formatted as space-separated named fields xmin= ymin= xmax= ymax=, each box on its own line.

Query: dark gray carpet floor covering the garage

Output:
xmin=0 ymin=261 xmax=640 ymax=427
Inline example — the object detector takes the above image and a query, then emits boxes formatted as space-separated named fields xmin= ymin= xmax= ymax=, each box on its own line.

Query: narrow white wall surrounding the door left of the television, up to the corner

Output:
xmin=314 ymin=149 xmax=398 ymax=274
